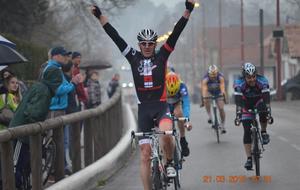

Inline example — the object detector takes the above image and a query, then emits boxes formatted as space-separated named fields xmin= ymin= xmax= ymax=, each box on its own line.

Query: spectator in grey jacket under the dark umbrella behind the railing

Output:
xmin=87 ymin=70 xmax=101 ymax=108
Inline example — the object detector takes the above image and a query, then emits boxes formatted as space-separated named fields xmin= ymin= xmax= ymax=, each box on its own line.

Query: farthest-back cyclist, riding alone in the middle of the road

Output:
xmin=201 ymin=65 xmax=226 ymax=133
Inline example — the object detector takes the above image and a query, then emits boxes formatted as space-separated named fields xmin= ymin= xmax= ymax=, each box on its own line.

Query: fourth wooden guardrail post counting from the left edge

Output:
xmin=70 ymin=122 xmax=81 ymax=173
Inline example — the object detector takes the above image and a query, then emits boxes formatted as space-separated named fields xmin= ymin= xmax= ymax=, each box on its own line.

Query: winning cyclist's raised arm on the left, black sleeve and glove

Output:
xmin=91 ymin=6 xmax=127 ymax=52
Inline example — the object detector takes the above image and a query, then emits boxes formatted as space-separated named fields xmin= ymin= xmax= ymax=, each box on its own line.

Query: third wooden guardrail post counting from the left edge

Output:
xmin=53 ymin=126 xmax=65 ymax=182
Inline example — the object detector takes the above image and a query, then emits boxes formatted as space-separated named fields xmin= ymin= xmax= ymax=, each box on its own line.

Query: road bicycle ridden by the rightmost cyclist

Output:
xmin=234 ymin=108 xmax=274 ymax=176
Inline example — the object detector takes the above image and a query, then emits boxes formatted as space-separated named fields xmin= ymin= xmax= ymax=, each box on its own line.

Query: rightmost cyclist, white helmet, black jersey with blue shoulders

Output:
xmin=233 ymin=63 xmax=271 ymax=170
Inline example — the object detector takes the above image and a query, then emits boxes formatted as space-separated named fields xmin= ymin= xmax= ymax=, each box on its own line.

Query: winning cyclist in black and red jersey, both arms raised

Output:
xmin=92 ymin=0 xmax=195 ymax=190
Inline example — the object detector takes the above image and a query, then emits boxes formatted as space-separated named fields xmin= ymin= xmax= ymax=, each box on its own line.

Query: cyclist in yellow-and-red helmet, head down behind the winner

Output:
xmin=166 ymin=71 xmax=192 ymax=157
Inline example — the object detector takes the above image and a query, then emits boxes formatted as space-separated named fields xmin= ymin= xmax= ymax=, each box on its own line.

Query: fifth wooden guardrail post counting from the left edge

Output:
xmin=84 ymin=119 xmax=94 ymax=167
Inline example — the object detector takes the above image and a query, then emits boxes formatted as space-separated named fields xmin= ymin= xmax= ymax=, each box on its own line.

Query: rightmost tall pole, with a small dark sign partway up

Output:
xmin=276 ymin=0 xmax=282 ymax=100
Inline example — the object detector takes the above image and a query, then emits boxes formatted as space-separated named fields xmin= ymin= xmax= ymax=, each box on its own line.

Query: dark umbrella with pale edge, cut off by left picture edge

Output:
xmin=0 ymin=44 xmax=28 ymax=65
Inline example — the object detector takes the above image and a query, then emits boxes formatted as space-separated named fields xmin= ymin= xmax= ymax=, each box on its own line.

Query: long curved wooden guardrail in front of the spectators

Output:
xmin=0 ymin=88 xmax=123 ymax=190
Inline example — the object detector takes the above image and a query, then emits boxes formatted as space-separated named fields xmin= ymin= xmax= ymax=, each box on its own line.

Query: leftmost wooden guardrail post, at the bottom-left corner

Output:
xmin=1 ymin=141 xmax=16 ymax=190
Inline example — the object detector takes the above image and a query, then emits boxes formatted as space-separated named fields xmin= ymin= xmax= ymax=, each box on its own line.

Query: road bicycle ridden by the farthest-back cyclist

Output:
xmin=203 ymin=95 xmax=225 ymax=143
